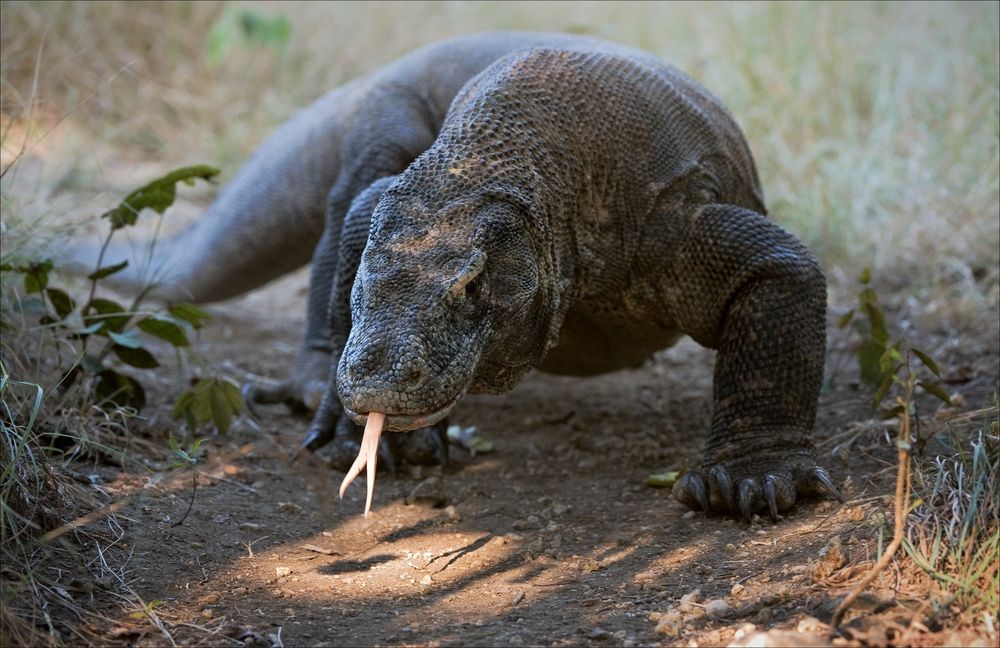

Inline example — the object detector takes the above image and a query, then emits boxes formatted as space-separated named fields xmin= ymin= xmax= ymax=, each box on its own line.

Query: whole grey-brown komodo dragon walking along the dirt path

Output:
xmin=80 ymin=32 xmax=840 ymax=519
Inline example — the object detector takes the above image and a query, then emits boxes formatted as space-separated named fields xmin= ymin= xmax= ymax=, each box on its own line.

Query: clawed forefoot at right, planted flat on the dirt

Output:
xmin=673 ymin=456 xmax=844 ymax=522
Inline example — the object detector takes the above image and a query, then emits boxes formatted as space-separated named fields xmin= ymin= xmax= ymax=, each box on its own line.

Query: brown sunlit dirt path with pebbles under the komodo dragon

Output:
xmin=54 ymin=260 xmax=996 ymax=646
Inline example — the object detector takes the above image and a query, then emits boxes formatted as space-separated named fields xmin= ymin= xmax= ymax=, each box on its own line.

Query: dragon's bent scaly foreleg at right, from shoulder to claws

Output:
xmin=664 ymin=205 xmax=841 ymax=520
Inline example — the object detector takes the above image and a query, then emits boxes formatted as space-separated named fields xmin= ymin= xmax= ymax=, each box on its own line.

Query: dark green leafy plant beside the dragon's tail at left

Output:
xmin=0 ymin=165 xmax=242 ymax=432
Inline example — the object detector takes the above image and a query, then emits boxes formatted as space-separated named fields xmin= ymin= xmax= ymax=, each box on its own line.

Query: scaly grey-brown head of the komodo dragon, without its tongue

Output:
xmin=337 ymin=175 xmax=558 ymax=430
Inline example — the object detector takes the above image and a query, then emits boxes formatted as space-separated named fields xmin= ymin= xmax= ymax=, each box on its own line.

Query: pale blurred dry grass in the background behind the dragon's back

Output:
xmin=0 ymin=2 xmax=1000 ymax=287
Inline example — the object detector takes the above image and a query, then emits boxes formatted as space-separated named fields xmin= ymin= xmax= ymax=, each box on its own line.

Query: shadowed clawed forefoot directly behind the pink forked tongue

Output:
xmin=322 ymin=416 xmax=448 ymax=473
